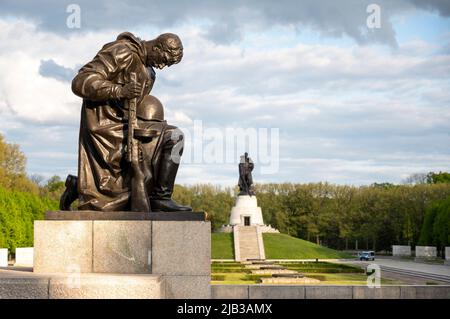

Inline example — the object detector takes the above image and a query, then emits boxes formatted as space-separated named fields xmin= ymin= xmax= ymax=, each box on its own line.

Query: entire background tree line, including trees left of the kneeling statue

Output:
xmin=0 ymin=135 xmax=450 ymax=254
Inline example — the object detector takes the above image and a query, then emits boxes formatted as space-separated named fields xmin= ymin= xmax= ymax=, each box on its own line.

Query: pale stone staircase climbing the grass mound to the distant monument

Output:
xmin=234 ymin=226 xmax=266 ymax=261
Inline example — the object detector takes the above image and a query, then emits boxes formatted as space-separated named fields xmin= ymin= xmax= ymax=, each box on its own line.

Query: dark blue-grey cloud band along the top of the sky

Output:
xmin=0 ymin=0 xmax=450 ymax=47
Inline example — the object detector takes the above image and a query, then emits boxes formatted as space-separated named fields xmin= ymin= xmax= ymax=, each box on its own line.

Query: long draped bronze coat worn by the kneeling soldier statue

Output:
xmin=72 ymin=32 xmax=165 ymax=211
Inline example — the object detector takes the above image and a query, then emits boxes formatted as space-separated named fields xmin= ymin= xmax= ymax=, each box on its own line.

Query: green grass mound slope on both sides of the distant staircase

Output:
xmin=211 ymin=233 xmax=352 ymax=259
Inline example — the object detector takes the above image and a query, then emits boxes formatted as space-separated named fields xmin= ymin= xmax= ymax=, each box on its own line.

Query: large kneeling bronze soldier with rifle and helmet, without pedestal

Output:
xmin=60 ymin=32 xmax=191 ymax=212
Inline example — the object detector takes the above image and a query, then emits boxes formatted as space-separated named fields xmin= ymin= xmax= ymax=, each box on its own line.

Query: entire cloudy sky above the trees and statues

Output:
xmin=0 ymin=0 xmax=450 ymax=185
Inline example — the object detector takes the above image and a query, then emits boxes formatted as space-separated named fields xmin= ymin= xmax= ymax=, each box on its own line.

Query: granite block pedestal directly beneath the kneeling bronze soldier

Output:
xmin=34 ymin=211 xmax=211 ymax=298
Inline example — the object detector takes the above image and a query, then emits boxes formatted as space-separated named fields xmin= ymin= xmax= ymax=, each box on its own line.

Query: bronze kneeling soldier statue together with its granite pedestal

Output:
xmin=33 ymin=32 xmax=211 ymax=298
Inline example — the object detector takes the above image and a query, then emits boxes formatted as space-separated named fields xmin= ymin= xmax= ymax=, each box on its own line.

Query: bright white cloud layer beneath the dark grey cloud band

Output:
xmin=0 ymin=15 xmax=450 ymax=185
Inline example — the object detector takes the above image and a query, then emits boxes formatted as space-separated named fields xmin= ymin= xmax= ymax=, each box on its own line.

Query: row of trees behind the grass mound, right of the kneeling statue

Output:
xmin=175 ymin=183 xmax=450 ymax=250
